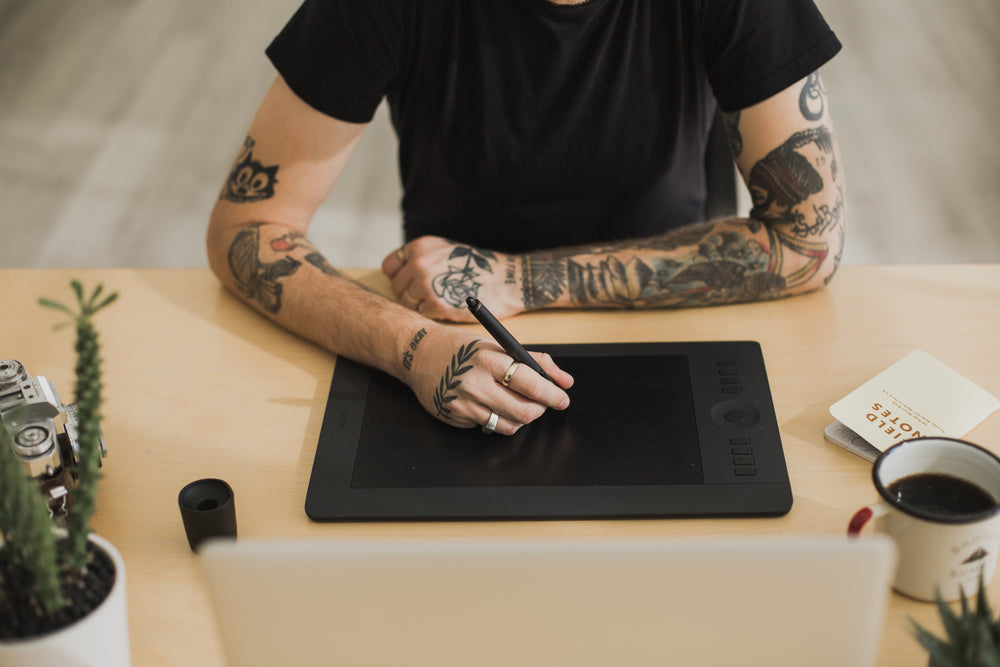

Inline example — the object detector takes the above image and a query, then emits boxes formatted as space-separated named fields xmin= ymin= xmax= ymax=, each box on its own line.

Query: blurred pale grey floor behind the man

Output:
xmin=0 ymin=0 xmax=1000 ymax=267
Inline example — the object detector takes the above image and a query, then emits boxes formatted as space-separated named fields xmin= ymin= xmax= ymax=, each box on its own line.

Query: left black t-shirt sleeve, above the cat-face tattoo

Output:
xmin=266 ymin=0 xmax=405 ymax=123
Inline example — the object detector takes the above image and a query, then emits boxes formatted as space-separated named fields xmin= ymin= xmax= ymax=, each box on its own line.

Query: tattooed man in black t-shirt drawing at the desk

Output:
xmin=208 ymin=0 xmax=846 ymax=434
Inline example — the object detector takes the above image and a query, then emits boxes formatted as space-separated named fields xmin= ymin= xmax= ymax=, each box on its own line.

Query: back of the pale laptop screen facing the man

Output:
xmin=200 ymin=536 xmax=896 ymax=667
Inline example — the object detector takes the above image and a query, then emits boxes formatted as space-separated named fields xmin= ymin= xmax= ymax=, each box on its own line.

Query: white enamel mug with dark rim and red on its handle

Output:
xmin=847 ymin=438 xmax=1000 ymax=601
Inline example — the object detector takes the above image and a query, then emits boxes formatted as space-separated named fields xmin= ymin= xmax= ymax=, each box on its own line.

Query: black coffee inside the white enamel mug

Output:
xmin=887 ymin=473 xmax=998 ymax=519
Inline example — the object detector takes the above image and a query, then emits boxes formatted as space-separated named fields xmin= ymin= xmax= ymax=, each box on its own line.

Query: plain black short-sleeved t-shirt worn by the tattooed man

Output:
xmin=267 ymin=0 xmax=840 ymax=252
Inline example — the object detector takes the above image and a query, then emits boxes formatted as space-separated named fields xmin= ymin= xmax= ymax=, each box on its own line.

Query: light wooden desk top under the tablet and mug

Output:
xmin=0 ymin=265 xmax=1000 ymax=666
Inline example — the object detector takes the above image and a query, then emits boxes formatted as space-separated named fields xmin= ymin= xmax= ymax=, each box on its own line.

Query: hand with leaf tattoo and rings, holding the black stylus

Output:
xmin=402 ymin=323 xmax=573 ymax=435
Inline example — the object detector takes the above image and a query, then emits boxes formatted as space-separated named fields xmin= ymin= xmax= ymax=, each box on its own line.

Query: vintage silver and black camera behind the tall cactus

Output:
xmin=0 ymin=359 xmax=107 ymax=517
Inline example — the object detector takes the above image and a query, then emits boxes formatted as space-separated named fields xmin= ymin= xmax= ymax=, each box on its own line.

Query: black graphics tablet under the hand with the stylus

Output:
xmin=306 ymin=342 xmax=792 ymax=521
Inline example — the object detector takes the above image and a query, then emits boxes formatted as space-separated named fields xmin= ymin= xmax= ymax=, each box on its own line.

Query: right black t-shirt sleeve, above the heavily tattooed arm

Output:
xmin=700 ymin=0 xmax=841 ymax=111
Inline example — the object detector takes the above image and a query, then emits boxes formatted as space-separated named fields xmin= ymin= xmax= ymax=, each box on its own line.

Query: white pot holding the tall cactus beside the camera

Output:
xmin=0 ymin=533 xmax=130 ymax=667
